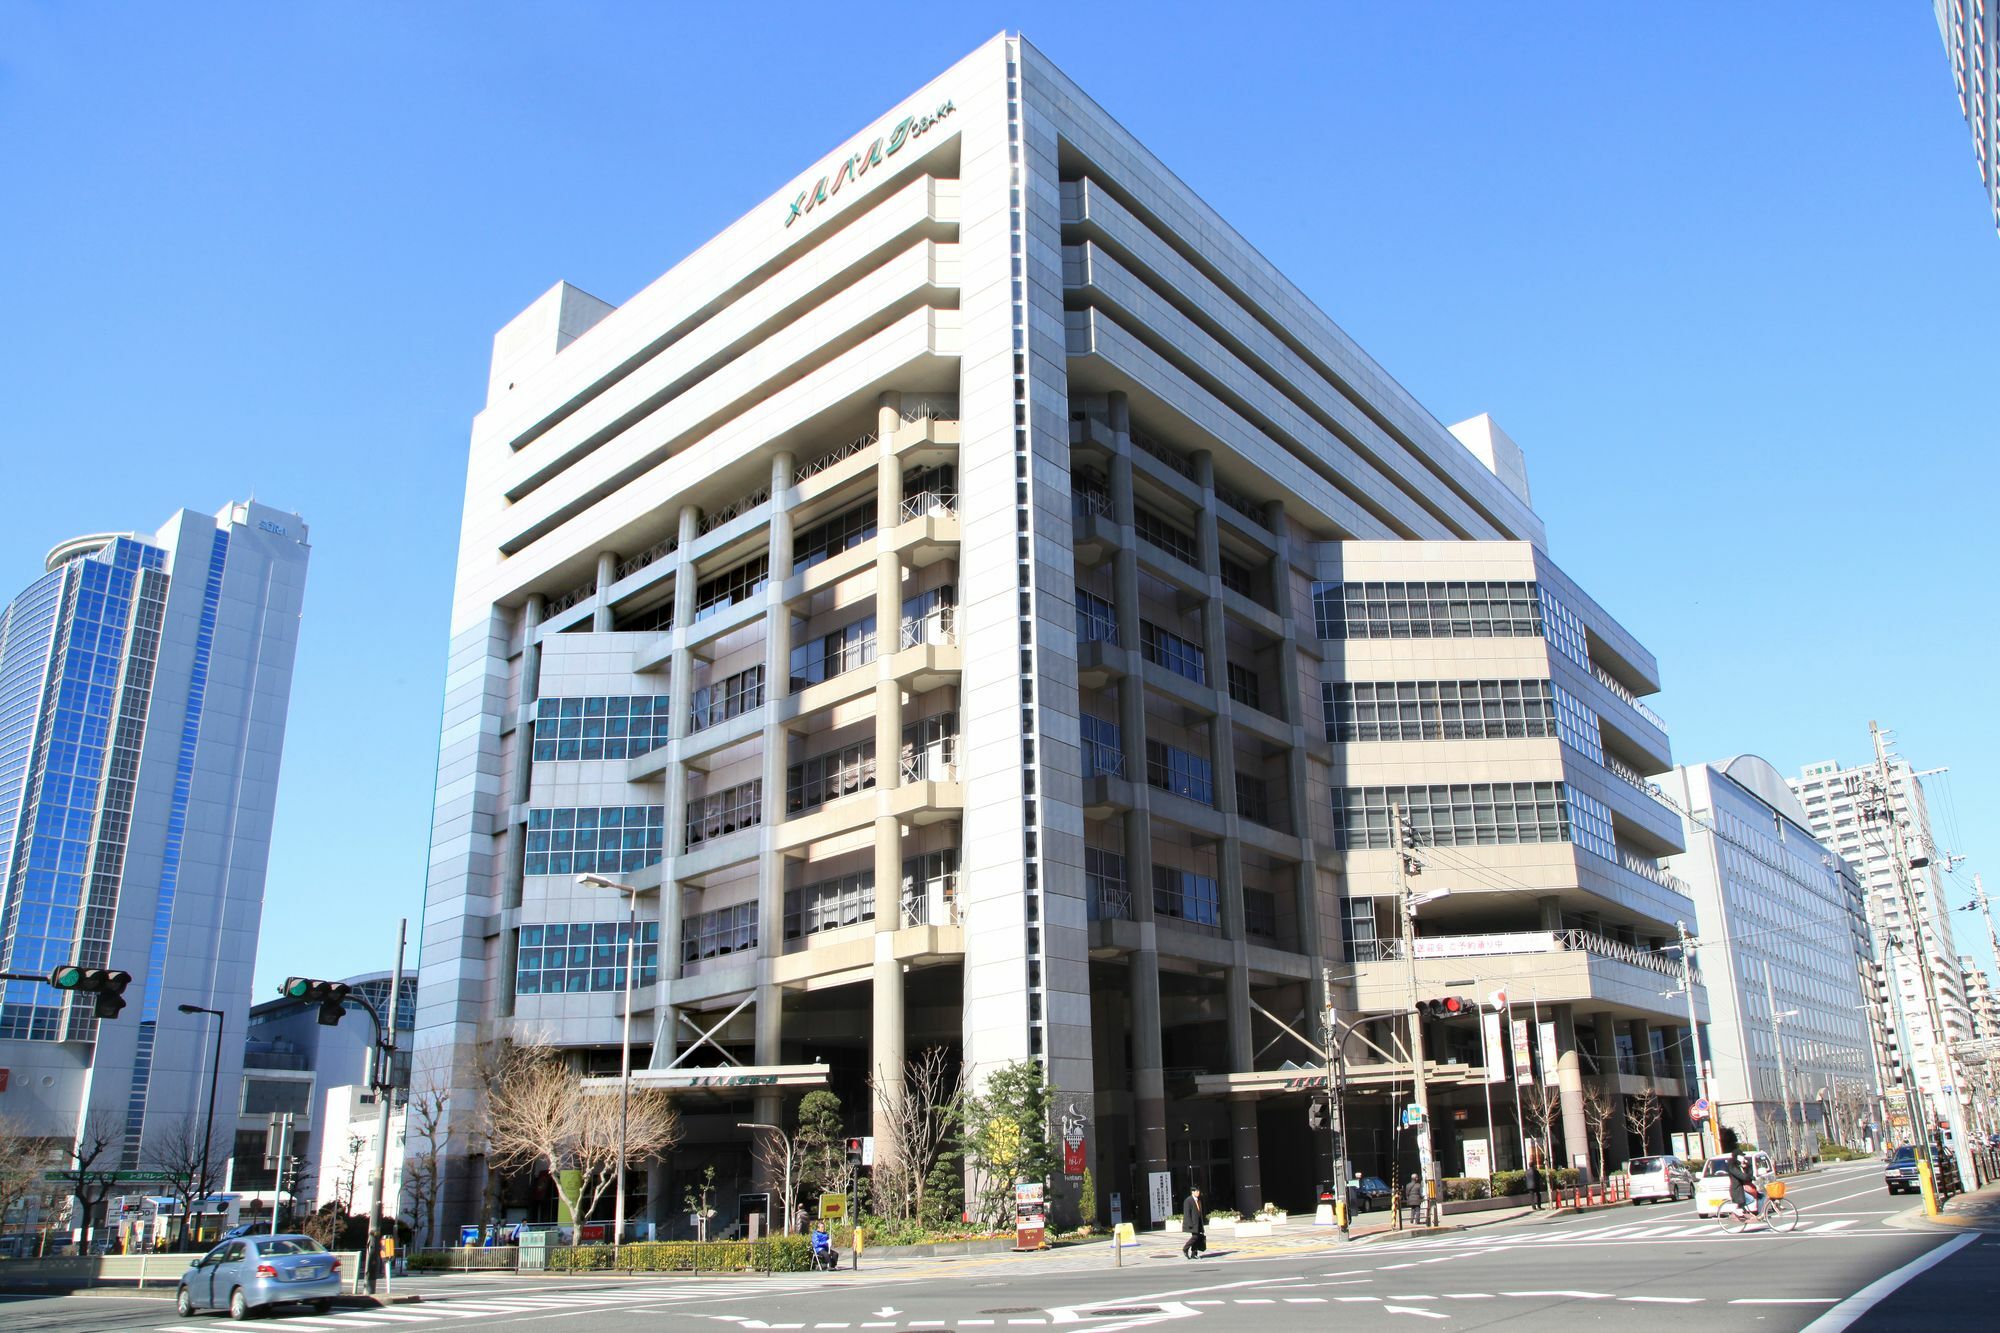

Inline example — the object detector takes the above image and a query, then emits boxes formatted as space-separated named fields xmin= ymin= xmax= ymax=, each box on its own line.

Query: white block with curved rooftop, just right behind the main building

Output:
xmin=1660 ymin=755 xmax=1880 ymax=1159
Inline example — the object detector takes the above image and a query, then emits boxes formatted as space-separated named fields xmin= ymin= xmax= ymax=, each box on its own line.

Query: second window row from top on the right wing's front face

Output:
xmin=1320 ymin=681 xmax=1558 ymax=743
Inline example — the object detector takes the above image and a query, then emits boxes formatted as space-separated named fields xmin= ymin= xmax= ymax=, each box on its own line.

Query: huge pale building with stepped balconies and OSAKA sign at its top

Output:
xmin=418 ymin=36 xmax=1692 ymax=1225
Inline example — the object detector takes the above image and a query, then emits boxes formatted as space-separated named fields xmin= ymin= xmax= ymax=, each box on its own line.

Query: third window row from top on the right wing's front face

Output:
xmin=1334 ymin=783 xmax=1570 ymax=851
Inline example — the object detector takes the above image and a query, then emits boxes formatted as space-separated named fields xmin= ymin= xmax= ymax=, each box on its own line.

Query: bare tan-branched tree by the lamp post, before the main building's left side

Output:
xmin=484 ymin=1047 xmax=680 ymax=1221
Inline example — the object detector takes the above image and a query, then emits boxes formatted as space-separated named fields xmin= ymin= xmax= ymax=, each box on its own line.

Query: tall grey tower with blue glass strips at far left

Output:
xmin=0 ymin=502 xmax=310 ymax=1169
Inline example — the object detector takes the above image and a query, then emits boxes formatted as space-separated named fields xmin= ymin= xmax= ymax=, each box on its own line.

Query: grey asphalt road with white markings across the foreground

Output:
xmin=0 ymin=1163 xmax=2000 ymax=1333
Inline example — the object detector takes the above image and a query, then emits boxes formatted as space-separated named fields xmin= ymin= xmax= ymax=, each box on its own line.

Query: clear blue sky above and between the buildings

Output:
xmin=0 ymin=0 xmax=2000 ymax=995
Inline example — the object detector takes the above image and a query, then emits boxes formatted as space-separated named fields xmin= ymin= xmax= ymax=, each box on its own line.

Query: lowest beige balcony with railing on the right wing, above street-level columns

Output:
xmin=1354 ymin=931 xmax=1708 ymax=1025
